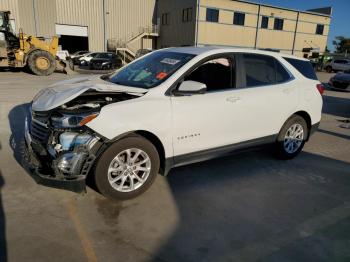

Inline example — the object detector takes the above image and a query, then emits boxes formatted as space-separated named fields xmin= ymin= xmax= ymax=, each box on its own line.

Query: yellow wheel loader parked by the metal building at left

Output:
xmin=0 ymin=11 xmax=65 ymax=76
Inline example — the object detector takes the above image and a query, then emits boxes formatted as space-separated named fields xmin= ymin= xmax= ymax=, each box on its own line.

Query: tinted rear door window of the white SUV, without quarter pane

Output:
xmin=243 ymin=54 xmax=276 ymax=87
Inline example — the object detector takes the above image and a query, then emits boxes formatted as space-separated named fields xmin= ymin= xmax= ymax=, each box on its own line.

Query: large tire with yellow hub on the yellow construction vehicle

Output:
xmin=27 ymin=50 xmax=56 ymax=76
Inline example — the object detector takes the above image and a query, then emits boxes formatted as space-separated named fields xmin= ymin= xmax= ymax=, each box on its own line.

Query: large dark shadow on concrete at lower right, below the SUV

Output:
xmin=156 ymin=151 xmax=350 ymax=262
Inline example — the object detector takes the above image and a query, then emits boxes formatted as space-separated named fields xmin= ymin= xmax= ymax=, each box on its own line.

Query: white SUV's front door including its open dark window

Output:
xmin=171 ymin=54 xmax=240 ymax=156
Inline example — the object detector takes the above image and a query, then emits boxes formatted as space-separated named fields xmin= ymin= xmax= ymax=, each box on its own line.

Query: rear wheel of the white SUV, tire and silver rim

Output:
xmin=276 ymin=115 xmax=308 ymax=159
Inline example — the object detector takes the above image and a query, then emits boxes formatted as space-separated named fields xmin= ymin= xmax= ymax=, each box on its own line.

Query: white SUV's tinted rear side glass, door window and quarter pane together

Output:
xmin=243 ymin=54 xmax=291 ymax=87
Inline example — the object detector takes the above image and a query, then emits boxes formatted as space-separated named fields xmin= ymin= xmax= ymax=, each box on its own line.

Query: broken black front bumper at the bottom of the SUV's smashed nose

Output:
xmin=24 ymin=115 xmax=86 ymax=193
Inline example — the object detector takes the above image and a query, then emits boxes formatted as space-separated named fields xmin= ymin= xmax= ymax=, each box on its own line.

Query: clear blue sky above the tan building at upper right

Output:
xmin=250 ymin=0 xmax=350 ymax=51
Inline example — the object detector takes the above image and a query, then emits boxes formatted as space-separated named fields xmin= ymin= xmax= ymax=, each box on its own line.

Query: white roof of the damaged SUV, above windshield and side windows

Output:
xmin=160 ymin=46 xmax=309 ymax=61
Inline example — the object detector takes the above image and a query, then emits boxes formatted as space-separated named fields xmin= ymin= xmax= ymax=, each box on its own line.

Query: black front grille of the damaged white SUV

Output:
xmin=30 ymin=112 xmax=50 ymax=143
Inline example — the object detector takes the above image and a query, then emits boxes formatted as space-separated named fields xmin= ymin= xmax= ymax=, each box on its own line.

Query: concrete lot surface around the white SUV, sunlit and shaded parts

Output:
xmin=0 ymin=69 xmax=350 ymax=262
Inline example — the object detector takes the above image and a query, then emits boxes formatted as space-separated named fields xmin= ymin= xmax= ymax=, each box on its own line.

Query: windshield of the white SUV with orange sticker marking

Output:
xmin=109 ymin=51 xmax=194 ymax=89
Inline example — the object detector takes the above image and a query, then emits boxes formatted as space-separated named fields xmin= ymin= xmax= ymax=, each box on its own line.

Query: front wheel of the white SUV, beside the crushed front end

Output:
xmin=95 ymin=135 xmax=160 ymax=200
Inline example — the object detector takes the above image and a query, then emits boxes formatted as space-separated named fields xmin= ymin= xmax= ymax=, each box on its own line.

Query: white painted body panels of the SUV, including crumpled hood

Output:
xmin=33 ymin=47 xmax=322 ymax=158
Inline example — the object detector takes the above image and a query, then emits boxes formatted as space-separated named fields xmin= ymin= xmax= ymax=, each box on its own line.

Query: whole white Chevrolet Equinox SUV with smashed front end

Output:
xmin=25 ymin=47 xmax=323 ymax=199
